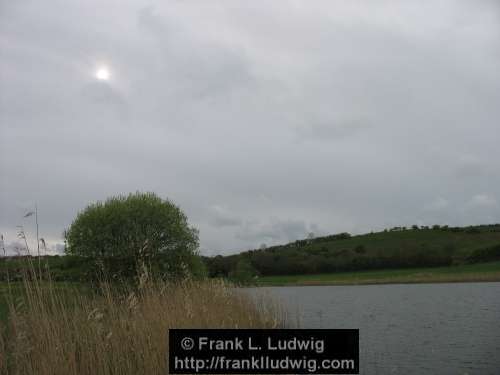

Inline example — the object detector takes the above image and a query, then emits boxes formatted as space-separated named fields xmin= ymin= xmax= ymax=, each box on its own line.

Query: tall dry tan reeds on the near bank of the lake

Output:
xmin=0 ymin=278 xmax=284 ymax=375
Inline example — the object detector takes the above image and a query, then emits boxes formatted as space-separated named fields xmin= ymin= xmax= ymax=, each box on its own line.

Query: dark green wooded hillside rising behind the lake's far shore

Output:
xmin=205 ymin=224 xmax=500 ymax=276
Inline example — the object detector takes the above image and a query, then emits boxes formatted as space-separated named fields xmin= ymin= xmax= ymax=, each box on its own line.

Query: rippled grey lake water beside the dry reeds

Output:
xmin=248 ymin=283 xmax=500 ymax=374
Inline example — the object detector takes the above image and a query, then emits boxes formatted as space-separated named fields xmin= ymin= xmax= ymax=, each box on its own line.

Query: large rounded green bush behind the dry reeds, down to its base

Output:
xmin=64 ymin=193 xmax=202 ymax=278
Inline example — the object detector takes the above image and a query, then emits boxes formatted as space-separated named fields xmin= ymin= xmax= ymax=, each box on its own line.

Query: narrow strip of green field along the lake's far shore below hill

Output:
xmin=257 ymin=262 xmax=500 ymax=286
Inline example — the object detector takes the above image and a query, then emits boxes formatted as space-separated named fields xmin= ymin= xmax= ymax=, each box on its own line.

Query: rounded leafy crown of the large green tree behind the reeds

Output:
xmin=64 ymin=192 xmax=198 ymax=261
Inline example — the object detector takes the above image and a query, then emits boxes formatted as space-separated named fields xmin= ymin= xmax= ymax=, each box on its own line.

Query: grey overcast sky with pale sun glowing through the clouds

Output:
xmin=0 ymin=0 xmax=500 ymax=254
